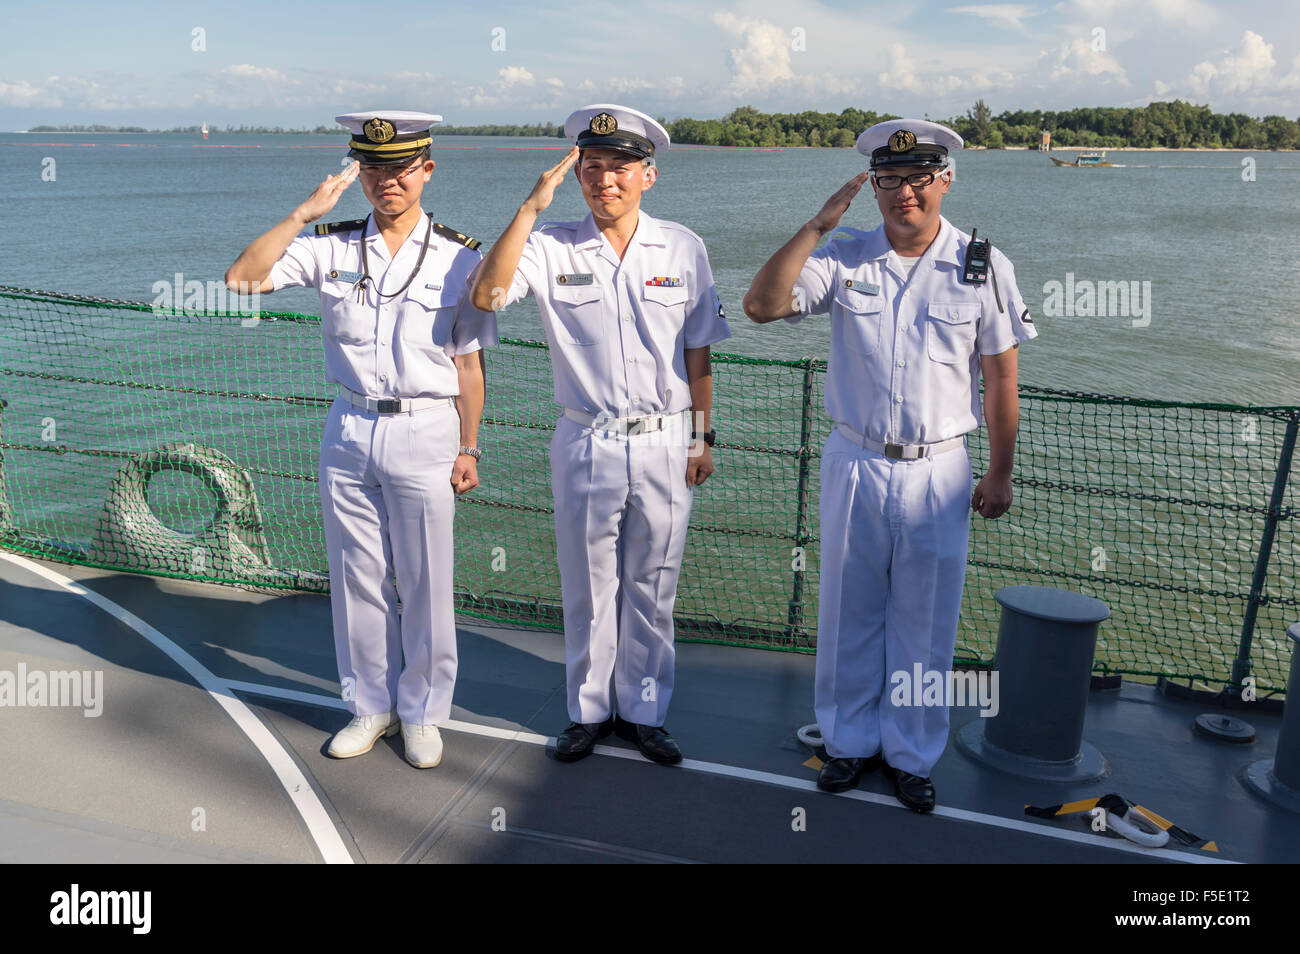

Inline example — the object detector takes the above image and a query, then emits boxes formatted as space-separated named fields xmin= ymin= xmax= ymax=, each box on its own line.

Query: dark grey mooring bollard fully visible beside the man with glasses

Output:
xmin=957 ymin=586 xmax=1110 ymax=782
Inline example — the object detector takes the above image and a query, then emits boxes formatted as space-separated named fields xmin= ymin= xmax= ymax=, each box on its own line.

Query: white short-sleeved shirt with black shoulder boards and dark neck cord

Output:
xmin=270 ymin=216 xmax=497 ymax=398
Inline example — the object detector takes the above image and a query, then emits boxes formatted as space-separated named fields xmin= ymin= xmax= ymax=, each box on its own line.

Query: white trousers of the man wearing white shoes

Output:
xmin=320 ymin=399 xmax=460 ymax=725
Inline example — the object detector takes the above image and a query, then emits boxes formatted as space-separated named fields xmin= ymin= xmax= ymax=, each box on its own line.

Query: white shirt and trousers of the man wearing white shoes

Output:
xmin=270 ymin=216 xmax=497 ymax=725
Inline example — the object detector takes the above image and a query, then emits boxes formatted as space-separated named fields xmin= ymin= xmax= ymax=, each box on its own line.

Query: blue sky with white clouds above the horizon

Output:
xmin=0 ymin=0 xmax=1300 ymax=131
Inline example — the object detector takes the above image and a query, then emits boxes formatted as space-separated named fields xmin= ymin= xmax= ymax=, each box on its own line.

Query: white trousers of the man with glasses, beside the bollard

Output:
xmin=814 ymin=430 xmax=972 ymax=777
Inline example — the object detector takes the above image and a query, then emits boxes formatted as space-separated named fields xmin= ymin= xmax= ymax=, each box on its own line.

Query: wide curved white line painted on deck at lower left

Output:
xmin=0 ymin=552 xmax=352 ymax=864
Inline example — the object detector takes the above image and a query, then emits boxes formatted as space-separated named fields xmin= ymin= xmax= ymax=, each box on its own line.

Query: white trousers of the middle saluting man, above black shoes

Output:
xmin=551 ymin=416 xmax=692 ymax=725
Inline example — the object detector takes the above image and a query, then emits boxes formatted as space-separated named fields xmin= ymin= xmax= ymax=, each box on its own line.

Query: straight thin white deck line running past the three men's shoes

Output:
xmin=226 ymin=682 xmax=1240 ymax=864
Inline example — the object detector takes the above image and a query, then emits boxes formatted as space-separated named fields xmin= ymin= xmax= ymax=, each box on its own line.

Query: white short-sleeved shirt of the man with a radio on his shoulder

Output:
xmin=787 ymin=217 xmax=1037 ymax=445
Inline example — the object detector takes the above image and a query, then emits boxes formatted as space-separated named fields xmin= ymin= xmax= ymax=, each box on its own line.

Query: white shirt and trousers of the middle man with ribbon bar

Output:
xmin=506 ymin=212 xmax=731 ymax=725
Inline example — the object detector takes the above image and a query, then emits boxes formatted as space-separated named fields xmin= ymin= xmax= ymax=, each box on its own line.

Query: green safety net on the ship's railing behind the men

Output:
xmin=0 ymin=286 xmax=1300 ymax=694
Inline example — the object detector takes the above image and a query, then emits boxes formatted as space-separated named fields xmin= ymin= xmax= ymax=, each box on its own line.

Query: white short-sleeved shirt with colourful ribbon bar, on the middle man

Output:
xmin=506 ymin=212 xmax=731 ymax=417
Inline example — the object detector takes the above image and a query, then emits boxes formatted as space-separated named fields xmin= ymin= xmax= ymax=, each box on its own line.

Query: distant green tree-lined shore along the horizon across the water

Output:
xmin=27 ymin=100 xmax=1300 ymax=149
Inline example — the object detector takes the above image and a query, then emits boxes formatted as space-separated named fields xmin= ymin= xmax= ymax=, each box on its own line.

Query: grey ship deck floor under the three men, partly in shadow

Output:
xmin=0 ymin=560 xmax=1300 ymax=863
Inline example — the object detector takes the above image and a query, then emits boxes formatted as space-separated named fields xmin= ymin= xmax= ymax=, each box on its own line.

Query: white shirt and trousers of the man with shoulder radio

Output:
xmin=788 ymin=217 xmax=1037 ymax=777
